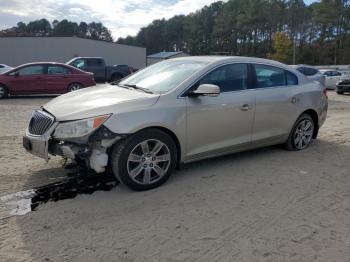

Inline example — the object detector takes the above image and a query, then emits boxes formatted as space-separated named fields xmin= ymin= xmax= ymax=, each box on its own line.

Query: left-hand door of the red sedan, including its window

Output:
xmin=8 ymin=64 xmax=45 ymax=95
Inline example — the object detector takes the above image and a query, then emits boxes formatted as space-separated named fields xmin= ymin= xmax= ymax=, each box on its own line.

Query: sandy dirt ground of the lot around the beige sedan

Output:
xmin=0 ymin=92 xmax=350 ymax=262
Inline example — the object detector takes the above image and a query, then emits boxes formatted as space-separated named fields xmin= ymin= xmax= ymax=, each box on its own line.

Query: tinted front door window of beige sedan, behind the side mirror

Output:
xmin=197 ymin=64 xmax=248 ymax=92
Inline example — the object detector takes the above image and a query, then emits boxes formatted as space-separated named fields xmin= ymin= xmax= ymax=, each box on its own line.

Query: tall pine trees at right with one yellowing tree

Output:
xmin=117 ymin=0 xmax=350 ymax=65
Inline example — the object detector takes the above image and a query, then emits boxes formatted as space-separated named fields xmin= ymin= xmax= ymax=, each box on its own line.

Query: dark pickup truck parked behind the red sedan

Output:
xmin=67 ymin=57 xmax=133 ymax=82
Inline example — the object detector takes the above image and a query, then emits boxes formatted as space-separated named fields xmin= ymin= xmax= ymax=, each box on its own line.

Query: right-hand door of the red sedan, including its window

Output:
xmin=46 ymin=65 xmax=72 ymax=94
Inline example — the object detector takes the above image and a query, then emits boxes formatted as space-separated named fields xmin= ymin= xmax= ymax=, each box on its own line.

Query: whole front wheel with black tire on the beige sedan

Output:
xmin=111 ymin=129 xmax=177 ymax=191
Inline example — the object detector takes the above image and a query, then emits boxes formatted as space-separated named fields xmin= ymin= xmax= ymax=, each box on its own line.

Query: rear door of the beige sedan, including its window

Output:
xmin=252 ymin=64 xmax=302 ymax=146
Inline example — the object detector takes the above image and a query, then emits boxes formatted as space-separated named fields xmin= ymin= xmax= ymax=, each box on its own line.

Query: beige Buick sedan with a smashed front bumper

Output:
xmin=23 ymin=57 xmax=328 ymax=190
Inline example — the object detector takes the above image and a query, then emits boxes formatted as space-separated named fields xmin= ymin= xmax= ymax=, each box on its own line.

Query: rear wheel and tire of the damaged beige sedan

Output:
xmin=285 ymin=114 xmax=315 ymax=151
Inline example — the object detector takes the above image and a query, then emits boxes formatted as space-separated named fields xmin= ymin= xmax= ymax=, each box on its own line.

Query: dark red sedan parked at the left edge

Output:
xmin=0 ymin=63 xmax=96 ymax=98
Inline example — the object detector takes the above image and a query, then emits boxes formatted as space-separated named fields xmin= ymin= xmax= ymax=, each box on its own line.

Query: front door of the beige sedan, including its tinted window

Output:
xmin=186 ymin=64 xmax=254 ymax=159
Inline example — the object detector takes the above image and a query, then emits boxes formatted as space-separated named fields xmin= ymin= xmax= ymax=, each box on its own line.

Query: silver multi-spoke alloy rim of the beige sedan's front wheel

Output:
xmin=127 ymin=139 xmax=171 ymax=185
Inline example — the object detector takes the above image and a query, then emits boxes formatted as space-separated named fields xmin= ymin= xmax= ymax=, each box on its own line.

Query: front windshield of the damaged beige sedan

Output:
xmin=118 ymin=60 xmax=206 ymax=93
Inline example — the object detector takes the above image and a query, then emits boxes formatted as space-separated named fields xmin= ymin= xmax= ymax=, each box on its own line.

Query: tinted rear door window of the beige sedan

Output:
xmin=255 ymin=65 xmax=286 ymax=88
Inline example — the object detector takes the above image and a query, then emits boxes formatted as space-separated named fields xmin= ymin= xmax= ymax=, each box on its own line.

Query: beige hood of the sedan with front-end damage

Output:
xmin=43 ymin=84 xmax=159 ymax=121
